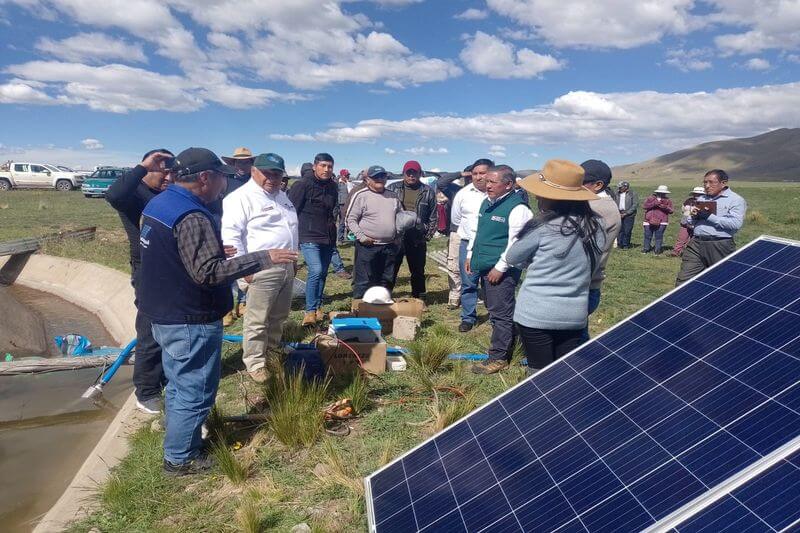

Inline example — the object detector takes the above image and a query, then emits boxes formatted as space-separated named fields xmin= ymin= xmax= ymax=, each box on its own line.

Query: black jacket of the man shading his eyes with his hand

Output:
xmin=106 ymin=165 xmax=160 ymax=281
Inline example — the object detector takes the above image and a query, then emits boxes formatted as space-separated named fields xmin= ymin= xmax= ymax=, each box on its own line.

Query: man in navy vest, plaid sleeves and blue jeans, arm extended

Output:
xmin=139 ymin=148 xmax=297 ymax=476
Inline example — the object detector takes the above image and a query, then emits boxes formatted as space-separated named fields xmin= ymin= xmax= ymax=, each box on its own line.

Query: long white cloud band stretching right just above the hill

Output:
xmin=272 ymin=82 xmax=800 ymax=152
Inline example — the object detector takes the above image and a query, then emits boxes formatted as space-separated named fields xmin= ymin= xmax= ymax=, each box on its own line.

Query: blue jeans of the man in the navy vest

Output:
xmin=153 ymin=320 xmax=222 ymax=465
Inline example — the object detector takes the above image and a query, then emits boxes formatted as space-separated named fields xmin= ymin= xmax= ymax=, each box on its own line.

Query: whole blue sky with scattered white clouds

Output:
xmin=0 ymin=0 xmax=800 ymax=171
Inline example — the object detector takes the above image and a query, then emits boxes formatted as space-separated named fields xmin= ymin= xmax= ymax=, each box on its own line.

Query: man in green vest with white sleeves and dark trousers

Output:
xmin=464 ymin=165 xmax=533 ymax=374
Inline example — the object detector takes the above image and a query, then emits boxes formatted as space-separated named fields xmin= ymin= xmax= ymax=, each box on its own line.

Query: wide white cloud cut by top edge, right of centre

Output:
xmin=486 ymin=0 xmax=696 ymax=48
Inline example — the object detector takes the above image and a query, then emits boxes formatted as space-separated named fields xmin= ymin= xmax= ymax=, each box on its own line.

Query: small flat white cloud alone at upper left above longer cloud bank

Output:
xmin=36 ymin=33 xmax=147 ymax=63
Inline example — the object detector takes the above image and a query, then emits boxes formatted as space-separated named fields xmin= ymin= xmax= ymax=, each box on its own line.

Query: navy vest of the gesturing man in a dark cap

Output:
xmin=137 ymin=185 xmax=233 ymax=324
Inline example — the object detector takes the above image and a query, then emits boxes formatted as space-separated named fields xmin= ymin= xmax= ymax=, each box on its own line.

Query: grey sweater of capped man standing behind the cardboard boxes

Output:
xmin=345 ymin=187 xmax=400 ymax=244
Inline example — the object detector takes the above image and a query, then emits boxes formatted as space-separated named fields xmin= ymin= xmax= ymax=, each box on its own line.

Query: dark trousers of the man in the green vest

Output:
xmin=481 ymin=268 xmax=521 ymax=361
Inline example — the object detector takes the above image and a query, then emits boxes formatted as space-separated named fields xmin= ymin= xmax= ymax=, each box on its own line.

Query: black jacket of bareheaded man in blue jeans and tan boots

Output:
xmin=288 ymin=170 xmax=339 ymax=246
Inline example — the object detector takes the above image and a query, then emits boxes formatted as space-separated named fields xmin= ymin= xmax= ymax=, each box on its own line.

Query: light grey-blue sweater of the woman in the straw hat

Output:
xmin=506 ymin=218 xmax=605 ymax=330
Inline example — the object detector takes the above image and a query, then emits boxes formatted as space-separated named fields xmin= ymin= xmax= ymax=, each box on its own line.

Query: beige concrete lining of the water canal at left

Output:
xmin=0 ymin=255 xmax=145 ymax=533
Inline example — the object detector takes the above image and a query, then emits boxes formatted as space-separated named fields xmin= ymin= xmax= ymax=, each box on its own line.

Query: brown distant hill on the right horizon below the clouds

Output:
xmin=614 ymin=128 xmax=800 ymax=181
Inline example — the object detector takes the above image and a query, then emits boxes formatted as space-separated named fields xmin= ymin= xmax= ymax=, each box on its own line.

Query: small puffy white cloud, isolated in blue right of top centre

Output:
xmin=460 ymin=31 xmax=564 ymax=79
